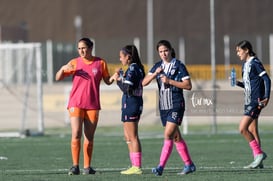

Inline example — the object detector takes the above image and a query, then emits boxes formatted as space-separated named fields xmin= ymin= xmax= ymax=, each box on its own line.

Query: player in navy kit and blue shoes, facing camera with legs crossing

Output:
xmin=143 ymin=40 xmax=196 ymax=176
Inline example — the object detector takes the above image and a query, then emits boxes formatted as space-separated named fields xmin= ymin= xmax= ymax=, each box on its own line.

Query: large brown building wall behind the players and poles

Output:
xmin=0 ymin=0 xmax=273 ymax=69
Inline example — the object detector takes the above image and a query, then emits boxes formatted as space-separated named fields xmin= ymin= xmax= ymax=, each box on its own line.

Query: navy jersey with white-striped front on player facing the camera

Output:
xmin=149 ymin=58 xmax=190 ymax=110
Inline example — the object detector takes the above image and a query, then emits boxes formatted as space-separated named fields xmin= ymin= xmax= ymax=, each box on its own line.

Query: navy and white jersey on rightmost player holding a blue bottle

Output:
xmin=242 ymin=57 xmax=271 ymax=105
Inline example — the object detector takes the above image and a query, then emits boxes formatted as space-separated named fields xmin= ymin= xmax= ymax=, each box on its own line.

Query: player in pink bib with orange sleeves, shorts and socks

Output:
xmin=56 ymin=38 xmax=113 ymax=175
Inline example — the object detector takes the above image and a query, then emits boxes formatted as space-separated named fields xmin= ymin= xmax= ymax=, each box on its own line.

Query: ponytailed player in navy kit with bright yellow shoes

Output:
xmin=111 ymin=45 xmax=145 ymax=175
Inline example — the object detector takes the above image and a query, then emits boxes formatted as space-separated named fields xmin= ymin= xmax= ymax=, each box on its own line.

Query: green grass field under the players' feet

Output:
xmin=0 ymin=126 xmax=273 ymax=181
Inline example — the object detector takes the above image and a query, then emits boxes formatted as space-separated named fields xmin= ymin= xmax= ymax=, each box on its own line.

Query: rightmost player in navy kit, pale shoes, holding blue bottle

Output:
xmin=236 ymin=40 xmax=271 ymax=168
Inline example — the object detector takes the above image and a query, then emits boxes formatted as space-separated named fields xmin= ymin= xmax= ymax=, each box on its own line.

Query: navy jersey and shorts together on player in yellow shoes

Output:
xmin=117 ymin=63 xmax=144 ymax=121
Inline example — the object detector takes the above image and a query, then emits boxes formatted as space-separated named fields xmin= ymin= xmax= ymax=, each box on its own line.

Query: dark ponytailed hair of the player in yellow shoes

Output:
xmin=121 ymin=45 xmax=145 ymax=76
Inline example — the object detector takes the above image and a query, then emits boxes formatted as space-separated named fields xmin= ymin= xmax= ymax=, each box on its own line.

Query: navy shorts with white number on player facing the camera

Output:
xmin=160 ymin=108 xmax=185 ymax=127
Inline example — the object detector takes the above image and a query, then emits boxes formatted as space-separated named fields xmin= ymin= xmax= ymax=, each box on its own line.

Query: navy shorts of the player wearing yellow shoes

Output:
xmin=121 ymin=96 xmax=143 ymax=122
